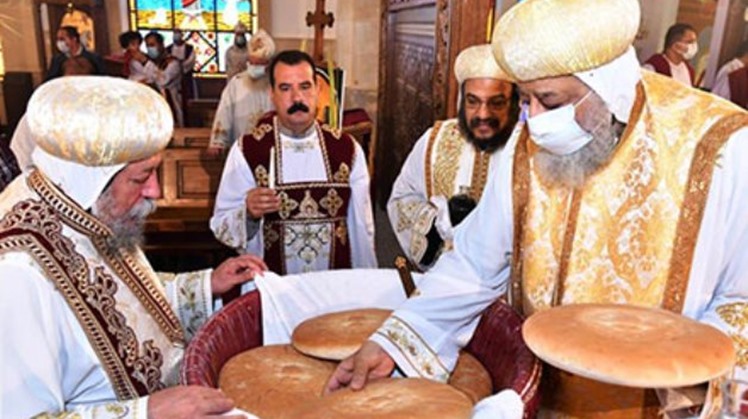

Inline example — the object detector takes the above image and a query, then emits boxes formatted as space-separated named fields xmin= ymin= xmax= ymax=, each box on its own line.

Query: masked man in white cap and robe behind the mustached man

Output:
xmin=208 ymin=29 xmax=275 ymax=156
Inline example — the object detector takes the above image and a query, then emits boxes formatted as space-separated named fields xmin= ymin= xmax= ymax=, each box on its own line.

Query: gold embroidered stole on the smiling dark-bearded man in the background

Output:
xmin=424 ymin=119 xmax=492 ymax=202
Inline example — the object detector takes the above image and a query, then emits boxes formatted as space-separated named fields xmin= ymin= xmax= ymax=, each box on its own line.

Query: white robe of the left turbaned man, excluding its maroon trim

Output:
xmin=0 ymin=172 xmax=212 ymax=419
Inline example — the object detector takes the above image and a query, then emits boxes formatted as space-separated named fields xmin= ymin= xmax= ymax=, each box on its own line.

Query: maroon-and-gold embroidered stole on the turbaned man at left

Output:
xmin=0 ymin=171 xmax=184 ymax=400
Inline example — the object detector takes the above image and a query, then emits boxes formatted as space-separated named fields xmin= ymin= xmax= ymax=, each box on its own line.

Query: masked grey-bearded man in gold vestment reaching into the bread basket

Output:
xmin=328 ymin=0 xmax=748 ymax=418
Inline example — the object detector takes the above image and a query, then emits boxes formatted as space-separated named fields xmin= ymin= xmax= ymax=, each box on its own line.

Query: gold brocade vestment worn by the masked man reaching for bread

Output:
xmin=510 ymin=72 xmax=748 ymax=418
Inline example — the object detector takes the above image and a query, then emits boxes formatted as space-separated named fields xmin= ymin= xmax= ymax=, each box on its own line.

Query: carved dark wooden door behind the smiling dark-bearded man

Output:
xmin=374 ymin=0 xmax=496 ymax=207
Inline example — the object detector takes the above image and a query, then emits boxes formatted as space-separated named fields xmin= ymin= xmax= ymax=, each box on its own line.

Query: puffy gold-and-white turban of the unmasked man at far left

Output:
xmin=26 ymin=76 xmax=174 ymax=166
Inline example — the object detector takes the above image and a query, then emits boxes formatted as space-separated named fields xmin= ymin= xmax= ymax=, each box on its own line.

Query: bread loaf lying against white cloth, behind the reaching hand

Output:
xmin=291 ymin=308 xmax=392 ymax=361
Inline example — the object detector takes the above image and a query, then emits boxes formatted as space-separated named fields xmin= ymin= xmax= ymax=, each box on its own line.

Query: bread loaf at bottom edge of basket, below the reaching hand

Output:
xmin=290 ymin=378 xmax=473 ymax=419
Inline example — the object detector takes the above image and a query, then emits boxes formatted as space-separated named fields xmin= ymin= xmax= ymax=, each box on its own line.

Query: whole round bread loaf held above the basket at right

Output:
xmin=522 ymin=304 xmax=735 ymax=388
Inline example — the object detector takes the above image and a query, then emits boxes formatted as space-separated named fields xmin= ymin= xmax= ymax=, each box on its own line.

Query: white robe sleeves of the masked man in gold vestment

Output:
xmin=371 ymin=128 xmax=748 ymax=380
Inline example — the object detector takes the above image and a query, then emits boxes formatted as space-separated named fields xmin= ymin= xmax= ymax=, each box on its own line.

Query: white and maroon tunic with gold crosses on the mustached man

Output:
xmin=210 ymin=117 xmax=376 ymax=274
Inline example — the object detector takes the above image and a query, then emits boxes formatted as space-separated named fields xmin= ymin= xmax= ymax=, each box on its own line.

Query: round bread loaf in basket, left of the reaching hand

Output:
xmin=218 ymin=345 xmax=336 ymax=418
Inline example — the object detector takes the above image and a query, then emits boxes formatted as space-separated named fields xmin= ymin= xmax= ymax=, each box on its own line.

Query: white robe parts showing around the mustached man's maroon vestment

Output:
xmin=210 ymin=130 xmax=377 ymax=273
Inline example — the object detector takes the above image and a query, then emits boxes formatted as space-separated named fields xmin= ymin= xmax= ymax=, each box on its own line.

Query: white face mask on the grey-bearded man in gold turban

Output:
xmin=527 ymin=90 xmax=593 ymax=155
